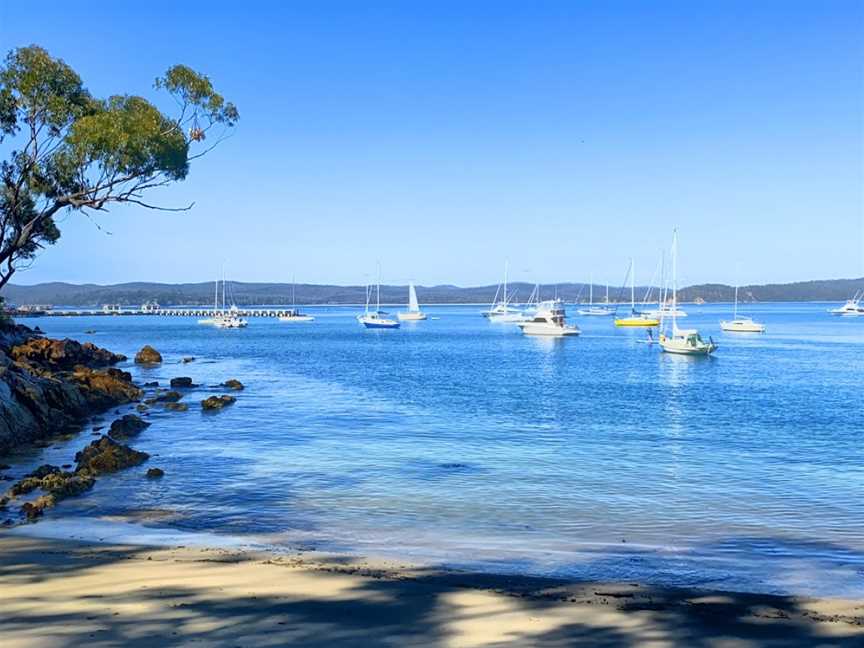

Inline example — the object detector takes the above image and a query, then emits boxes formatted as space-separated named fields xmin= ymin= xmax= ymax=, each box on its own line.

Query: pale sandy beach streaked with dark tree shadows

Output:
xmin=0 ymin=534 xmax=864 ymax=648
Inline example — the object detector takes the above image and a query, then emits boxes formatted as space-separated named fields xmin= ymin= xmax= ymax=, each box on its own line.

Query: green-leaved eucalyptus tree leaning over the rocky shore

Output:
xmin=0 ymin=45 xmax=239 ymax=288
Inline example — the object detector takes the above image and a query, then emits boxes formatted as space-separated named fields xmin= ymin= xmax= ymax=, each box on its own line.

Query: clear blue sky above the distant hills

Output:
xmin=0 ymin=0 xmax=864 ymax=285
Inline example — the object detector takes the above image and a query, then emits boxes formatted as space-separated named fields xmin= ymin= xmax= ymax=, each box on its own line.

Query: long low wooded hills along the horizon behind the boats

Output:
xmin=0 ymin=278 xmax=864 ymax=307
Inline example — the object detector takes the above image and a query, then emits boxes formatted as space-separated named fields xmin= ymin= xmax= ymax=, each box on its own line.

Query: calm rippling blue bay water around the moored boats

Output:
xmin=6 ymin=304 xmax=864 ymax=596
